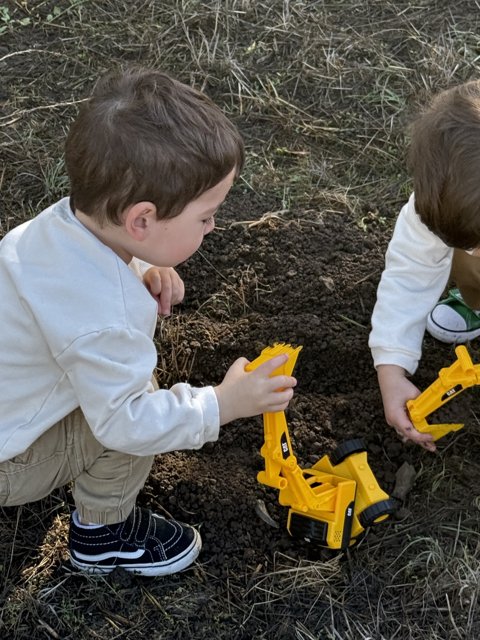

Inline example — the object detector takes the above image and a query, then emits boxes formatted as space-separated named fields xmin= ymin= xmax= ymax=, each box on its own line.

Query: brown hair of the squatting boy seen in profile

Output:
xmin=65 ymin=68 xmax=244 ymax=225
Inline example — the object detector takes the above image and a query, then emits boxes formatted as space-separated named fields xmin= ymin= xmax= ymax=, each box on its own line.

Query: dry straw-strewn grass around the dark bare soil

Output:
xmin=0 ymin=0 xmax=480 ymax=640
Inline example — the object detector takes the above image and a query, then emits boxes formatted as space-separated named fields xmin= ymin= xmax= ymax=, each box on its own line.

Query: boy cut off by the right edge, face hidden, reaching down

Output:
xmin=369 ymin=81 xmax=480 ymax=451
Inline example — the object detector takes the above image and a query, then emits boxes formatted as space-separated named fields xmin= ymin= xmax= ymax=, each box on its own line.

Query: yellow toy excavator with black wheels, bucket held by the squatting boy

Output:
xmin=247 ymin=344 xmax=396 ymax=549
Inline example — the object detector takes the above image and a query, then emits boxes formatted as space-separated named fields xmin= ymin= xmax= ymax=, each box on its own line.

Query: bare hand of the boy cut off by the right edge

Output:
xmin=377 ymin=364 xmax=436 ymax=451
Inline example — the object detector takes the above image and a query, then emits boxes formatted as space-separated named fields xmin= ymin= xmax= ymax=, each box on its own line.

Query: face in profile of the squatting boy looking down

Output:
xmin=137 ymin=170 xmax=235 ymax=267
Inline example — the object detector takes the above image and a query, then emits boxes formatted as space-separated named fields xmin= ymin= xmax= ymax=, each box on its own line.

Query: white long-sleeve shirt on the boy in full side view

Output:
xmin=0 ymin=198 xmax=219 ymax=461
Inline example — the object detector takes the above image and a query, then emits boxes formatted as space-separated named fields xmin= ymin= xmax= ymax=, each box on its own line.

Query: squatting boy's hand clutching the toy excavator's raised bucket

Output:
xmin=215 ymin=354 xmax=297 ymax=424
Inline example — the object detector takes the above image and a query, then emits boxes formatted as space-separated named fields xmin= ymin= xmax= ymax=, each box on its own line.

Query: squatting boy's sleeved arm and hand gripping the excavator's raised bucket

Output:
xmin=62 ymin=330 xmax=296 ymax=455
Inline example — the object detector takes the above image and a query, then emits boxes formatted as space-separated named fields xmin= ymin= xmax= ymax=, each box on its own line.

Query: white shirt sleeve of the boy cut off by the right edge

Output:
xmin=369 ymin=194 xmax=453 ymax=373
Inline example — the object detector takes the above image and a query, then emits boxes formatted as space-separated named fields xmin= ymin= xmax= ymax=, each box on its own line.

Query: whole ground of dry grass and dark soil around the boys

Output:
xmin=0 ymin=0 xmax=480 ymax=640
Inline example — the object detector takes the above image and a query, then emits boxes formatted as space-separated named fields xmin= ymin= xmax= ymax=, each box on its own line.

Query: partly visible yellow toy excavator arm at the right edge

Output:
xmin=407 ymin=345 xmax=480 ymax=440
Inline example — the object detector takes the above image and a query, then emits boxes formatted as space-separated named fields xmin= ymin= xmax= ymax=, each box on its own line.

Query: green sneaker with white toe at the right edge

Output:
xmin=427 ymin=289 xmax=480 ymax=344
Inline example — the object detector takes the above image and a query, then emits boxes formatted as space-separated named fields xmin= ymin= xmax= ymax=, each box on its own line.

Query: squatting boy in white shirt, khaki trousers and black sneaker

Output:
xmin=0 ymin=69 xmax=296 ymax=576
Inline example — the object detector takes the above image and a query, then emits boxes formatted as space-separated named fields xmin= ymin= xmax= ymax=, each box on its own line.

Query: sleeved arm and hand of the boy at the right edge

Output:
xmin=369 ymin=196 xmax=453 ymax=451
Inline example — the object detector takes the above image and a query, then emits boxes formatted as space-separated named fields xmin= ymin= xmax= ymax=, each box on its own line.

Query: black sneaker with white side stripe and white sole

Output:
xmin=69 ymin=507 xmax=202 ymax=576
